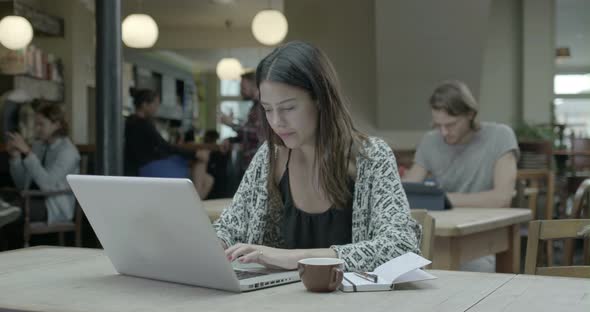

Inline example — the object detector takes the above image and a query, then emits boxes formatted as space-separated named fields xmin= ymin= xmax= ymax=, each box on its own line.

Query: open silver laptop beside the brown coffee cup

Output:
xmin=67 ymin=175 xmax=299 ymax=292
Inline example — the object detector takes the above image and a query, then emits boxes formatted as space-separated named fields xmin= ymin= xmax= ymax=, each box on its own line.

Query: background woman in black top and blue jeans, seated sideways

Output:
xmin=124 ymin=88 xmax=213 ymax=198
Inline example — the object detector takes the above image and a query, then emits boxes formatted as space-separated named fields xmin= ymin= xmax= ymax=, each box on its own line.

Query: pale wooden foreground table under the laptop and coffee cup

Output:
xmin=0 ymin=247 xmax=590 ymax=312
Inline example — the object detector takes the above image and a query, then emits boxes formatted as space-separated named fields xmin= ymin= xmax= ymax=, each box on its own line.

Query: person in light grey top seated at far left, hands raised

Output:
xmin=6 ymin=104 xmax=80 ymax=223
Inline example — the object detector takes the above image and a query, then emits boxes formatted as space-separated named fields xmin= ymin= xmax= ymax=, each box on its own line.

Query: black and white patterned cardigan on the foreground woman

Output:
xmin=214 ymin=138 xmax=421 ymax=271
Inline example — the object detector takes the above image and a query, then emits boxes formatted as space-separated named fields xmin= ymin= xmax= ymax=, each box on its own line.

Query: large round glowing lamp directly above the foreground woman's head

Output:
xmin=252 ymin=10 xmax=289 ymax=45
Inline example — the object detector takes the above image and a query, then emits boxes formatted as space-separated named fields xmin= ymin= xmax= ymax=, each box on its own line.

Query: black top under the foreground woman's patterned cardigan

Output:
xmin=279 ymin=150 xmax=354 ymax=249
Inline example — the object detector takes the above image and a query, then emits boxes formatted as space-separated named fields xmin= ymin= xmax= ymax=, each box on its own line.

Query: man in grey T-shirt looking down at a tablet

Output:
xmin=403 ymin=81 xmax=519 ymax=208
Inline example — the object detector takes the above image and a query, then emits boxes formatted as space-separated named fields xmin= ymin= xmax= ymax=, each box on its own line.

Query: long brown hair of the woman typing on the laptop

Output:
xmin=256 ymin=41 xmax=366 ymax=207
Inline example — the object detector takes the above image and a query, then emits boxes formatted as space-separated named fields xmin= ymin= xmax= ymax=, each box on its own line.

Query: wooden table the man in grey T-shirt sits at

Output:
xmin=429 ymin=208 xmax=532 ymax=273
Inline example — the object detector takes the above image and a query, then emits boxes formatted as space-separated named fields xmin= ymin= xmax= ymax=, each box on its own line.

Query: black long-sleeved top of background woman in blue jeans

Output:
xmin=125 ymin=115 xmax=195 ymax=176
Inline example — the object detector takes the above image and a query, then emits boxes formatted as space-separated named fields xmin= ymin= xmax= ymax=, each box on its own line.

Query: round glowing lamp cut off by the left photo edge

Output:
xmin=0 ymin=15 xmax=33 ymax=50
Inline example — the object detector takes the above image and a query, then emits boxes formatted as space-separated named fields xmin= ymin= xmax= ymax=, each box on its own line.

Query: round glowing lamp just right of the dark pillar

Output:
xmin=122 ymin=14 xmax=158 ymax=49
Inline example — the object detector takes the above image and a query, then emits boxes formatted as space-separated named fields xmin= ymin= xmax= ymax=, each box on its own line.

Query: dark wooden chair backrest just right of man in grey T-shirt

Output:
xmin=518 ymin=141 xmax=553 ymax=169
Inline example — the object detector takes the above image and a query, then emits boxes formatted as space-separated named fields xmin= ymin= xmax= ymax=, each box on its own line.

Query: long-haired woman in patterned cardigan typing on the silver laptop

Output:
xmin=214 ymin=41 xmax=421 ymax=270
